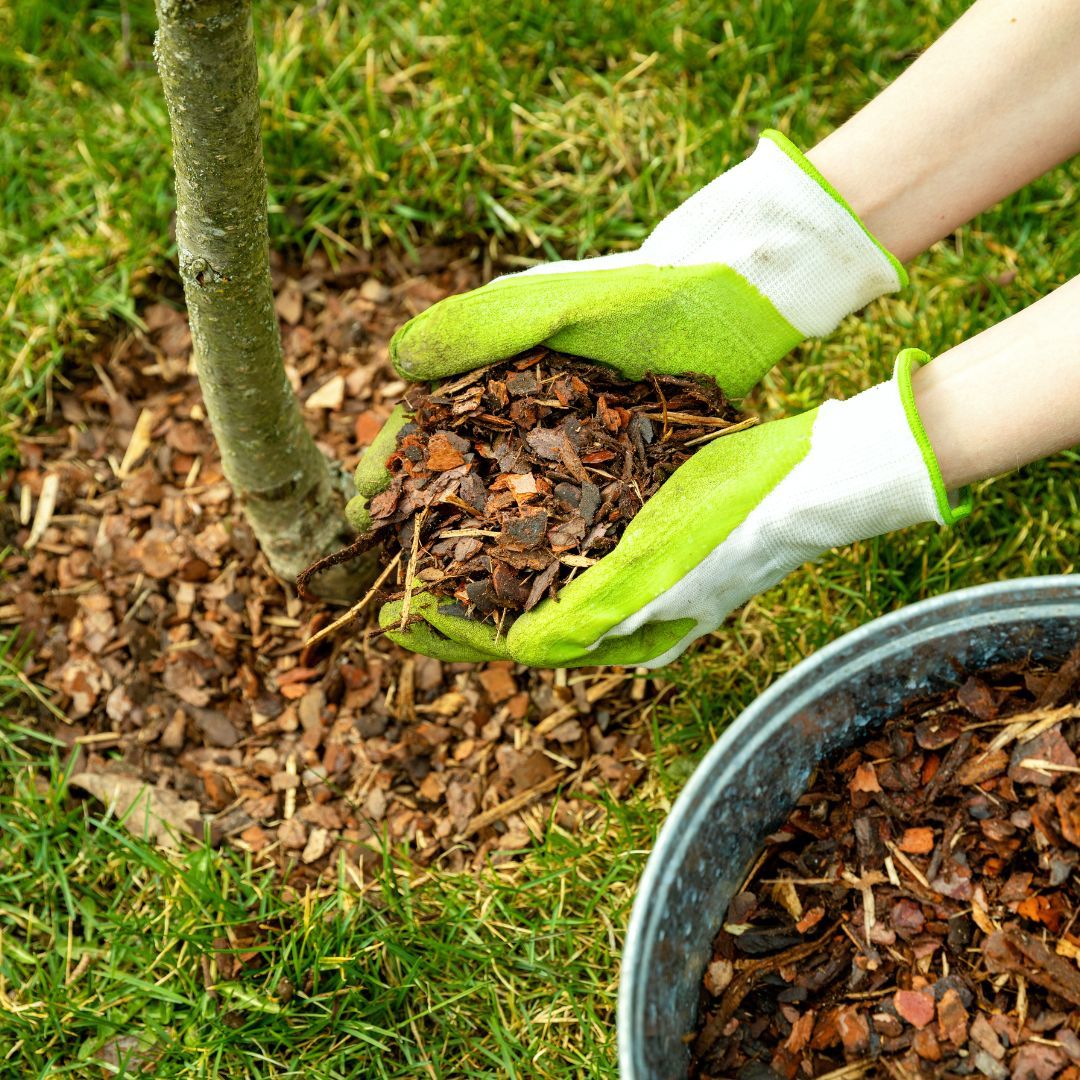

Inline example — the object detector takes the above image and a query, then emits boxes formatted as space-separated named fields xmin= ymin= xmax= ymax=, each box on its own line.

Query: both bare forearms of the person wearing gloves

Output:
xmin=807 ymin=0 xmax=1080 ymax=487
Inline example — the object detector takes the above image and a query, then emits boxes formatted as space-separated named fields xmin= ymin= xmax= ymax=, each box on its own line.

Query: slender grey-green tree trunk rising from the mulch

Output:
xmin=154 ymin=0 xmax=370 ymax=599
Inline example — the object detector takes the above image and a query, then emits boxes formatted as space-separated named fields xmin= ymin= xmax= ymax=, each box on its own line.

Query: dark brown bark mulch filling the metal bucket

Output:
xmin=691 ymin=647 xmax=1080 ymax=1080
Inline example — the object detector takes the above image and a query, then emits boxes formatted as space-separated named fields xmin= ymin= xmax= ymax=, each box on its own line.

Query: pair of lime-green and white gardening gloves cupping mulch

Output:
xmin=348 ymin=132 xmax=970 ymax=667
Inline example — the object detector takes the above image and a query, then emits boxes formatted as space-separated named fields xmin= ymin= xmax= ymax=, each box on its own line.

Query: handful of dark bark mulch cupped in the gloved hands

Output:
xmin=332 ymin=348 xmax=752 ymax=626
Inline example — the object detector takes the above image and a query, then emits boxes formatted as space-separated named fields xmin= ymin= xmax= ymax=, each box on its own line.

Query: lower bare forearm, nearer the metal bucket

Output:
xmin=912 ymin=278 xmax=1080 ymax=489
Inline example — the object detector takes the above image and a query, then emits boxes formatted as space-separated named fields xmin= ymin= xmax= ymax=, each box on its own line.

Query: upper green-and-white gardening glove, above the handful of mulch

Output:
xmin=390 ymin=131 xmax=907 ymax=397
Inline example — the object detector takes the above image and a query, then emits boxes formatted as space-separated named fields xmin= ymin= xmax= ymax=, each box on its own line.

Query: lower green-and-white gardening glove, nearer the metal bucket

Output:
xmin=380 ymin=349 xmax=971 ymax=667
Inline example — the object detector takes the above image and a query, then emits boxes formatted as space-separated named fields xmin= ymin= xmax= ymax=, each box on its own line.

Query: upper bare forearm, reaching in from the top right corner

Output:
xmin=808 ymin=0 xmax=1080 ymax=261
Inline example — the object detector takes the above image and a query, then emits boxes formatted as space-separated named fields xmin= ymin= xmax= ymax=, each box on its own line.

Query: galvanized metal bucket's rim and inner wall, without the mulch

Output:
xmin=618 ymin=576 xmax=1080 ymax=1080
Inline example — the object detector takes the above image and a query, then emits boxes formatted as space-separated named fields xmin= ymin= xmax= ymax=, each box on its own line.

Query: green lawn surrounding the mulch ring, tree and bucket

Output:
xmin=0 ymin=0 xmax=1080 ymax=1078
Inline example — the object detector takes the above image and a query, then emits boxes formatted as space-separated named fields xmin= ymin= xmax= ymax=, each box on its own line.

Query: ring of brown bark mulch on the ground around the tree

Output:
xmin=0 ymin=248 xmax=665 ymax=885
